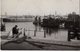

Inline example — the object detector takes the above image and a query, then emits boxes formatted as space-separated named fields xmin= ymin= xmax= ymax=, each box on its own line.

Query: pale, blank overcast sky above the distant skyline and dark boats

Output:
xmin=2 ymin=0 xmax=79 ymax=15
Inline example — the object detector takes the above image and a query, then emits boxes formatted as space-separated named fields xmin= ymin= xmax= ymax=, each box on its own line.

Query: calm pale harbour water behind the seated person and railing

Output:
xmin=6 ymin=22 xmax=67 ymax=41
